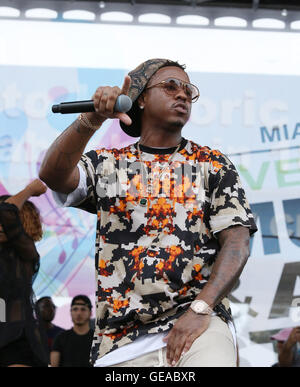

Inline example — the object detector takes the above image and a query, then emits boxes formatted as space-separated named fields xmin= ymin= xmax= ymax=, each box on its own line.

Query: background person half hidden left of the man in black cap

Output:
xmin=36 ymin=296 xmax=65 ymax=353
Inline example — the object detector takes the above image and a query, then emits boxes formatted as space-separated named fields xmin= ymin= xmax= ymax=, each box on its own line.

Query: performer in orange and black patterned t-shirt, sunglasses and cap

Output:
xmin=39 ymin=58 xmax=256 ymax=367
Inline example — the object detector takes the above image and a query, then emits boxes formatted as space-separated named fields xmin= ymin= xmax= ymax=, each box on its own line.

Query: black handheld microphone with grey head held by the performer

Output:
xmin=52 ymin=94 xmax=132 ymax=114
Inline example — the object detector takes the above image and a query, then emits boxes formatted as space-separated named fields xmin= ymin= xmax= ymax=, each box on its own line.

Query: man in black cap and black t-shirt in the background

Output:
xmin=50 ymin=295 xmax=94 ymax=367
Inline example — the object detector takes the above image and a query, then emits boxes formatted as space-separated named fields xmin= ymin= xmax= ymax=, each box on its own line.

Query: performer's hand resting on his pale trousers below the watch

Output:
xmin=164 ymin=309 xmax=211 ymax=366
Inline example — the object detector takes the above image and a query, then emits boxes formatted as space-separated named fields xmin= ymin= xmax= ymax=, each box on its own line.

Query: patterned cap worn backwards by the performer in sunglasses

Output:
xmin=120 ymin=58 xmax=182 ymax=137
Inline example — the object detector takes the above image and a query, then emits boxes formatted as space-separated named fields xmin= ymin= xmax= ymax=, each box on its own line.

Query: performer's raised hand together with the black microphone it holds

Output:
xmin=52 ymin=75 xmax=132 ymax=126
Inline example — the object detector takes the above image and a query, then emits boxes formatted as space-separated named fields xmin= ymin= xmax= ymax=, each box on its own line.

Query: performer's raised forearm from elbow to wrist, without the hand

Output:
xmin=39 ymin=116 xmax=95 ymax=193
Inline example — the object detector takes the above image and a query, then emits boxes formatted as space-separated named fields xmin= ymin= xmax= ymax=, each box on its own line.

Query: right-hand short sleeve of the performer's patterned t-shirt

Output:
xmin=209 ymin=158 xmax=257 ymax=235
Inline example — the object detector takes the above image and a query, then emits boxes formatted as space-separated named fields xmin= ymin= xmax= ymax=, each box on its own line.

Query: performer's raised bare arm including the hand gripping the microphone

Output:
xmin=39 ymin=76 xmax=131 ymax=194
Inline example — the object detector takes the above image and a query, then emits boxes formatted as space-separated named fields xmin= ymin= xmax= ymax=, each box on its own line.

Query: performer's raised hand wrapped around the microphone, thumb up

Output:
xmin=86 ymin=75 xmax=131 ymax=125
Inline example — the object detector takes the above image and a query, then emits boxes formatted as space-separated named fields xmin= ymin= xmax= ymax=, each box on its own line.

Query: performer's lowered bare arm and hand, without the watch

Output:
xmin=164 ymin=226 xmax=250 ymax=366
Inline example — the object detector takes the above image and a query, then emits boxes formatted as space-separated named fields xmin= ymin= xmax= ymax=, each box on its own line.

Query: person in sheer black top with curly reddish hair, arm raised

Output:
xmin=0 ymin=179 xmax=49 ymax=367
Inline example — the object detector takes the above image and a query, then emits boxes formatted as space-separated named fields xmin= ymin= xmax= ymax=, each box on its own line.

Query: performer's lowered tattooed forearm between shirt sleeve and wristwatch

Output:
xmin=197 ymin=226 xmax=249 ymax=308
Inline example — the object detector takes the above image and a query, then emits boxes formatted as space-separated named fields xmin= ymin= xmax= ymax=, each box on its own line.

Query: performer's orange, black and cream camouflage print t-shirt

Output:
xmin=74 ymin=139 xmax=256 ymax=360
